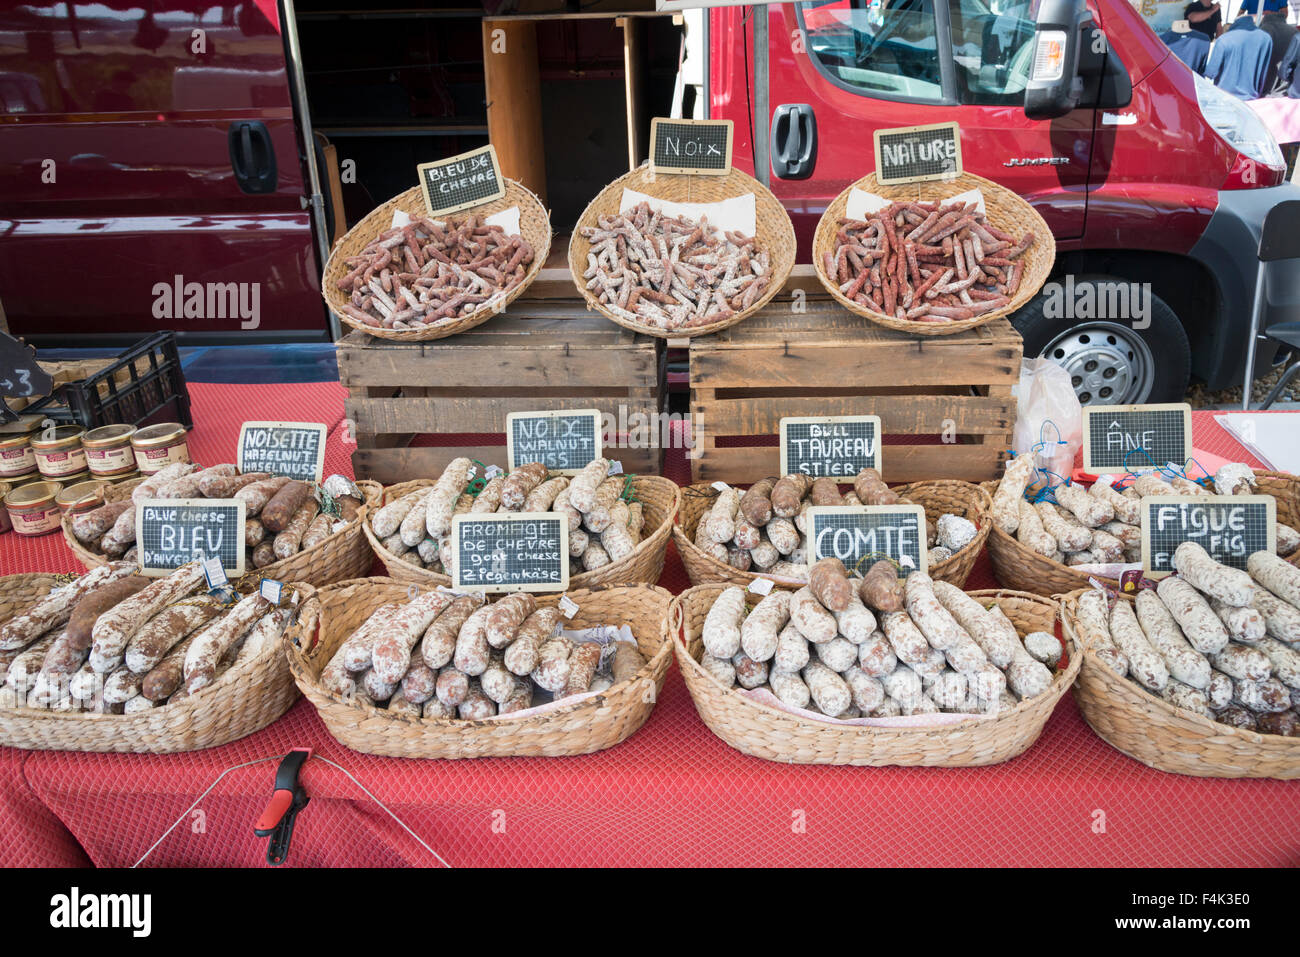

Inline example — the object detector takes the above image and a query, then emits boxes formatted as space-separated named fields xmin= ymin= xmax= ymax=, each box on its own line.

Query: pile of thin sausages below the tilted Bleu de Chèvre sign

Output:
xmin=338 ymin=216 xmax=533 ymax=329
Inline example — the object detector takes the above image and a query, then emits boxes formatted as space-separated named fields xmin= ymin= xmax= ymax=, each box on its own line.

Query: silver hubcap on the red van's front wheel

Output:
xmin=1043 ymin=322 xmax=1156 ymax=406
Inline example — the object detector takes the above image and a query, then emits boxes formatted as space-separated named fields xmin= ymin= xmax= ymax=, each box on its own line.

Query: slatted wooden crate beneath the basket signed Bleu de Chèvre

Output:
xmin=337 ymin=300 xmax=666 ymax=485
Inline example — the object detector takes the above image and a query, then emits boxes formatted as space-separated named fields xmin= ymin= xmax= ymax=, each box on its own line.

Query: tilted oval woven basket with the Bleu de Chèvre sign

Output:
xmin=321 ymin=179 xmax=551 ymax=342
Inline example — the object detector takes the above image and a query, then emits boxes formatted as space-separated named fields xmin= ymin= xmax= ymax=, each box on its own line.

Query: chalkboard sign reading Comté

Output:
xmin=807 ymin=505 xmax=926 ymax=576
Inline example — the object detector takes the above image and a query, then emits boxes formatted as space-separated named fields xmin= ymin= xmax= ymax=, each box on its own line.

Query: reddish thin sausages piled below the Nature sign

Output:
xmin=823 ymin=203 xmax=1034 ymax=322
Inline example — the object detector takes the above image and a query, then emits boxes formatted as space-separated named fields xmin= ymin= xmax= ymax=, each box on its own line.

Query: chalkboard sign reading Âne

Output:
xmin=1083 ymin=402 xmax=1192 ymax=475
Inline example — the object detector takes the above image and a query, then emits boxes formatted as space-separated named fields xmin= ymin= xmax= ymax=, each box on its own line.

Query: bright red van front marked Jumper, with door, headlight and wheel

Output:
xmin=709 ymin=0 xmax=1300 ymax=404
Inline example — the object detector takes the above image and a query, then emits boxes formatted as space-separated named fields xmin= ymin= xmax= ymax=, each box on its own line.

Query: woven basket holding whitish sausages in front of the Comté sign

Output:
xmin=670 ymin=584 xmax=1079 ymax=767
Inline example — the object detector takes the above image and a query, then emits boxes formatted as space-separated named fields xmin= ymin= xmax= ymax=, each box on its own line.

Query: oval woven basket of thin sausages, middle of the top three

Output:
xmin=569 ymin=164 xmax=796 ymax=339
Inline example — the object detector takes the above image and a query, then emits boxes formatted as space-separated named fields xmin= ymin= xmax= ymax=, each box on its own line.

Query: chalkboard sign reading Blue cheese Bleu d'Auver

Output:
xmin=135 ymin=498 xmax=244 ymax=579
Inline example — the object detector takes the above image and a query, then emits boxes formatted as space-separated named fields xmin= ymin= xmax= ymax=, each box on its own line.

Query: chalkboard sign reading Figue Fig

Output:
xmin=1141 ymin=495 xmax=1278 ymax=577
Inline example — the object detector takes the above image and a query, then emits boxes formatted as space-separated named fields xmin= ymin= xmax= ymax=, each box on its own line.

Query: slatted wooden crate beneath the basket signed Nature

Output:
xmin=690 ymin=299 xmax=1023 ymax=482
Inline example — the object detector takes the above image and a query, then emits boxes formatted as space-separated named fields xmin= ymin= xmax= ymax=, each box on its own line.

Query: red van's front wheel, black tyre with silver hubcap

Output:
xmin=1011 ymin=276 xmax=1192 ymax=406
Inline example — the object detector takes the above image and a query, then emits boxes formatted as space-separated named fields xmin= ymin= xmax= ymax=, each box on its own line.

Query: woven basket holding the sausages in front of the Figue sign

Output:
xmin=1061 ymin=590 xmax=1300 ymax=780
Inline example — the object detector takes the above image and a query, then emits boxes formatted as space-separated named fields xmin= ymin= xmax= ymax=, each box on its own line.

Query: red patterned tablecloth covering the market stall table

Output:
xmin=0 ymin=385 xmax=1300 ymax=866
